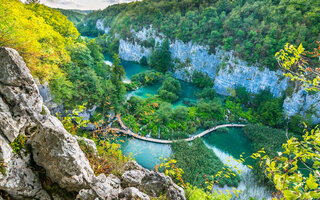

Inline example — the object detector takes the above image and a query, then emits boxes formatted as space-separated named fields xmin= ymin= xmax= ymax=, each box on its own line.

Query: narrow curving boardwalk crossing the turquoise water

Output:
xmin=104 ymin=114 xmax=246 ymax=144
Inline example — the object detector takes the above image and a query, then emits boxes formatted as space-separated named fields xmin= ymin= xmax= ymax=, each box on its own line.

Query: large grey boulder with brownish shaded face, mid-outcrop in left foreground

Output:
xmin=31 ymin=116 xmax=94 ymax=191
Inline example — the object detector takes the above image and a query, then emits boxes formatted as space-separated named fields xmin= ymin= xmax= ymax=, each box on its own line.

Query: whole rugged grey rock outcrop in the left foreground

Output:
xmin=0 ymin=48 xmax=185 ymax=200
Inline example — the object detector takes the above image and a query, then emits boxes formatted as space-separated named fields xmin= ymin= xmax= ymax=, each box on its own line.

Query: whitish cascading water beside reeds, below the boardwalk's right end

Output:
xmin=204 ymin=141 xmax=272 ymax=200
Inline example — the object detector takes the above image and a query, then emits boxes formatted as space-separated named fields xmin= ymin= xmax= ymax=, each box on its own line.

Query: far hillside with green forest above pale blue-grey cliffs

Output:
xmin=78 ymin=0 xmax=320 ymax=122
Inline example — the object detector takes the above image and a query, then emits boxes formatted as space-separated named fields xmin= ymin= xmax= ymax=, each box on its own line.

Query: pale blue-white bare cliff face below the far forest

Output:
xmin=97 ymin=23 xmax=320 ymax=122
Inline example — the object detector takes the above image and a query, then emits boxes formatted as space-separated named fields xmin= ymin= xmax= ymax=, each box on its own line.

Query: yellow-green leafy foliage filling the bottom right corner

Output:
xmin=253 ymin=128 xmax=320 ymax=199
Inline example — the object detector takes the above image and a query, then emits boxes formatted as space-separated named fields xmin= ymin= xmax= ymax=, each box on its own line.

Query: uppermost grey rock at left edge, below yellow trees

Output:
xmin=0 ymin=47 xmax=42 ymax=142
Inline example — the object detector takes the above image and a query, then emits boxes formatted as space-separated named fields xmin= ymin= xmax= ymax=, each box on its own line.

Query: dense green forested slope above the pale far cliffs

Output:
xmin=79 ymin=0 xmax=320 ymax=69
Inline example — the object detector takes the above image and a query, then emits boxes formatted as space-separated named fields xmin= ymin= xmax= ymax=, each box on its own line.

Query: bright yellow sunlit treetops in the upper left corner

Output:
xmin=0 ymin=0 xmax=80 ymax=81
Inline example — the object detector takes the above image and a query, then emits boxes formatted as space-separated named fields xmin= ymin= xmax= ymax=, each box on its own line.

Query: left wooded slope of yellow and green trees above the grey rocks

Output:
xmin=0 ymin=0 xmax=122 ymax=111
